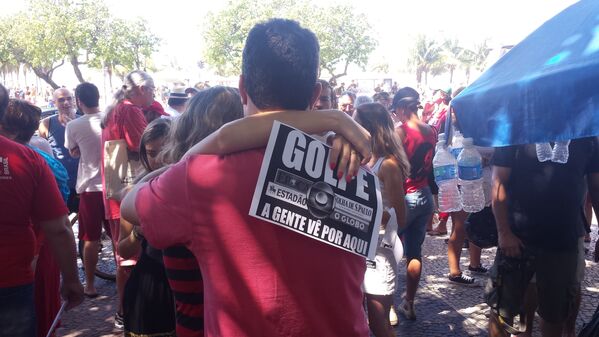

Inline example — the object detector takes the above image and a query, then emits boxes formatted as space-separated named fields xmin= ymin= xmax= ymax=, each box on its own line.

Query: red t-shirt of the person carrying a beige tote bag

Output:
xmin=101 ymin=100 xmax=148 ymax=219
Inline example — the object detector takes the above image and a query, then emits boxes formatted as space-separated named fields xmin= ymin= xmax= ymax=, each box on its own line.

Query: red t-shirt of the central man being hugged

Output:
xmin=136 ymin=150 xmax=368 ymax=336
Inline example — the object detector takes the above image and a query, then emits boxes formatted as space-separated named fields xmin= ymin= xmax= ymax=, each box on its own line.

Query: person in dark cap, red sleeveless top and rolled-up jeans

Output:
xmin=390 ymin=87 xmax=437 ymax=320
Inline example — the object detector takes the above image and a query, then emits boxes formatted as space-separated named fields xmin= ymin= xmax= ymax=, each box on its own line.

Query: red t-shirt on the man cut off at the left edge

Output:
xmin=0 ymin=136 xmax=68 ymax=288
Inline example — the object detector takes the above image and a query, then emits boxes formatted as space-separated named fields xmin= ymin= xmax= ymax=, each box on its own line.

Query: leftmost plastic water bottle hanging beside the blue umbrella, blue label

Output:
xmin=433 ymin=134 xmax=462 ymax=212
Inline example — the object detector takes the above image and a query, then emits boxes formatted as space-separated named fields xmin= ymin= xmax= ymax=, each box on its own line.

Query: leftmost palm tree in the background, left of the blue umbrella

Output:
xmin=408 ymin=35 xmax=443 ymax=85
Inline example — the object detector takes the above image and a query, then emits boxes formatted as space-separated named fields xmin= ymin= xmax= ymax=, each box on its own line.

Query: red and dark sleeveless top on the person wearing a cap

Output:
xmin=400 ymin=124 xmax=437 ymax=193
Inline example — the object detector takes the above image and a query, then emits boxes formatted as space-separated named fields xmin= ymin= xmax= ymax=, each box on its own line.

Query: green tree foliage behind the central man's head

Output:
xmin=204 ymin=0 xmax=377 ymax=79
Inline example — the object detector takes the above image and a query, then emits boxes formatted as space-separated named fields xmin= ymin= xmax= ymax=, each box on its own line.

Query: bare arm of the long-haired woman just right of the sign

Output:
xmin=379 ymin=159 xmax=407 ymax=229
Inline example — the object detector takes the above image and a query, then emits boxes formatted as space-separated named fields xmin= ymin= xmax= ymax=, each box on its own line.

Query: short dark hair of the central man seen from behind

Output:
xmin=242 ymin=19 xmax=320 ymax=110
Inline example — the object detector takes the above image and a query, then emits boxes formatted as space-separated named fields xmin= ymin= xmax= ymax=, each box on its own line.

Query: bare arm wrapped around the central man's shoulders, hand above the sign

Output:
xmin=183 ymin=110 xmax=371 ymax=173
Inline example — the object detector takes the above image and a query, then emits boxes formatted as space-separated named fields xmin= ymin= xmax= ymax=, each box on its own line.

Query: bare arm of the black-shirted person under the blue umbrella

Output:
xmin=492 ymin=166 xmax=524 ymax=257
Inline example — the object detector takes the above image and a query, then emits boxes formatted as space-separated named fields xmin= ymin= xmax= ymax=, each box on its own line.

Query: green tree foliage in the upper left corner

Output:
xmin=0 ymin=0 xmax=159 ymax=88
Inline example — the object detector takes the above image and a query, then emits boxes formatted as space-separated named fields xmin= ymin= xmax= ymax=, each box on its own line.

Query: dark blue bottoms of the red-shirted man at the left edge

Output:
xmin=0 ymin=283 xmax=36 ymax=337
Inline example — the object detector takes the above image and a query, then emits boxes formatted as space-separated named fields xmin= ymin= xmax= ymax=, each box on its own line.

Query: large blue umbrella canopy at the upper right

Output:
xmin=451 ymin=0 xmax=599 ymax=146
